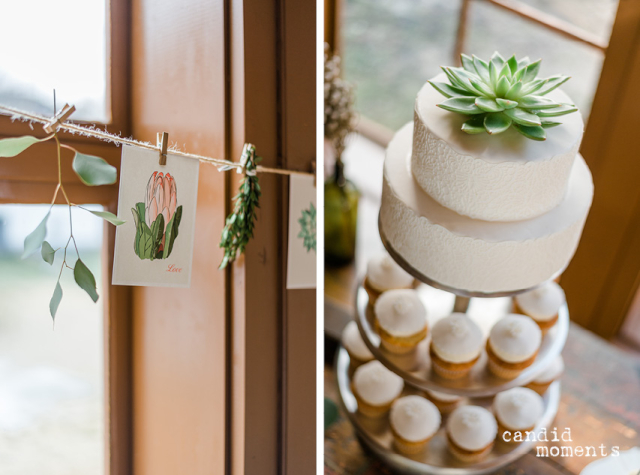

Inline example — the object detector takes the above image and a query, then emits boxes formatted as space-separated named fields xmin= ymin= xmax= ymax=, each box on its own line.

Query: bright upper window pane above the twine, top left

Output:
xmin=0 ymin=0 xmax=111 ymax=123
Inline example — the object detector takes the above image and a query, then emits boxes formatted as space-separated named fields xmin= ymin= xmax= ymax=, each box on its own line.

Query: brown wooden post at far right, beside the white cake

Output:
xmin=562 ymin=0 xmax=640 ymax=338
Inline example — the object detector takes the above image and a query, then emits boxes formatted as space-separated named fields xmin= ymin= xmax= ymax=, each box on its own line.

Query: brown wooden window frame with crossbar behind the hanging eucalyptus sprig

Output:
xmin=0 ymin=0 xmax=133 ymax=475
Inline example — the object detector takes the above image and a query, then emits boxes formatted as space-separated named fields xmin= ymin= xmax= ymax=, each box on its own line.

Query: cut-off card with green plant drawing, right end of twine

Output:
xmin=287 ymin=175 xmax=317 ymax=289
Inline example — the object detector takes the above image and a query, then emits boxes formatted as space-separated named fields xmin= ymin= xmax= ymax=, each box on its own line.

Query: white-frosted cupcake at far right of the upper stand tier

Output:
xmin=514 ymin=282 xmax=565 ymax=335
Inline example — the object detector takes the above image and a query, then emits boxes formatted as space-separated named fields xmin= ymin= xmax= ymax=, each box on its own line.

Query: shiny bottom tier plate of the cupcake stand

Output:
xmin=336 ymin=347 xmax=560 ymax=475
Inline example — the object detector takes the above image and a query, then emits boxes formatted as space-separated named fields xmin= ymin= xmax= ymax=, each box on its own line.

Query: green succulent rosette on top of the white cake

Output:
xmin=429 ymin=52 xmax=578 ymax=140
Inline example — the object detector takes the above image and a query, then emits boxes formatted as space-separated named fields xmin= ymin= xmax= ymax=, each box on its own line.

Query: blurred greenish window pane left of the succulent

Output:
xmin=342 ymin=0 xmax=459 ymax=129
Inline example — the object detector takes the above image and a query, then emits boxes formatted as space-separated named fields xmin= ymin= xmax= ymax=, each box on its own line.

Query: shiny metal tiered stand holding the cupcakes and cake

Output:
xmin=336 ymin=221 xmax=569 ymax=475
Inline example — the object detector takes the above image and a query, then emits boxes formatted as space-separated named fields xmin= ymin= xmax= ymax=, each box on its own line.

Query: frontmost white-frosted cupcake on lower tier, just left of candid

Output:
xmin=447 ymin=406 xmax=498 ymax=463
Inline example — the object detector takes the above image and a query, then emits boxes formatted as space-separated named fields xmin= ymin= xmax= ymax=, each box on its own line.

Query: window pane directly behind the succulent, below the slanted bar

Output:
xmin=464 ymin=2 xmax=604 ymax=120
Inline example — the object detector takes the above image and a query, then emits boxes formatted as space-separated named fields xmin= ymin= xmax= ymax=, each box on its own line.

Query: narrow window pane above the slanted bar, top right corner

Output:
xmin=520 ymin=0 xmax=618 ymax=42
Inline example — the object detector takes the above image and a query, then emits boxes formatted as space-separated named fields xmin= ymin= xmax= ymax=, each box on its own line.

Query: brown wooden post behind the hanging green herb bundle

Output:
xmin=227 ymin=0 xmax=316 ymax=475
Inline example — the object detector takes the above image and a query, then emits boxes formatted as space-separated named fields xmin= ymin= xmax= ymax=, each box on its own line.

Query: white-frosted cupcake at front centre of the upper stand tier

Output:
xmin=429 ymin=313 xmax=484 ymax=379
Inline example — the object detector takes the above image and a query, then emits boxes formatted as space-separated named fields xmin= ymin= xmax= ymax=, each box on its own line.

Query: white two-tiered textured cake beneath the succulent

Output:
xmin=380 ymin=73 xmax=593 ymax=293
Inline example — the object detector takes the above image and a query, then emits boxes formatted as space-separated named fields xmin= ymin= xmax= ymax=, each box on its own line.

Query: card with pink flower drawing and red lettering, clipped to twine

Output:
xmin=113 ymin=145 xmax=199 ymax=287
